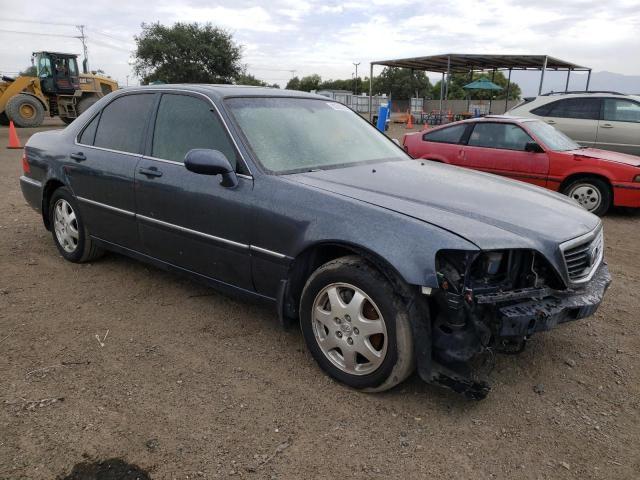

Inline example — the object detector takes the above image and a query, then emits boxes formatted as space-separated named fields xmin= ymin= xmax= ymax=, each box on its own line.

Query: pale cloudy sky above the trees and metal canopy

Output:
xmin=0 ymin=0 xmax=640 ymax=86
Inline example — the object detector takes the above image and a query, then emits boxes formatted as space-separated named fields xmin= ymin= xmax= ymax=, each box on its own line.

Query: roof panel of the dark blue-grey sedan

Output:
xmin=119 ymin=83 xmax=328 ymax=101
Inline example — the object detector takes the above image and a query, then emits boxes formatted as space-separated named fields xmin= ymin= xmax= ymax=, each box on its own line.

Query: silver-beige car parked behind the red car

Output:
xmin=507 ymin=92 xmax=640 ymax=155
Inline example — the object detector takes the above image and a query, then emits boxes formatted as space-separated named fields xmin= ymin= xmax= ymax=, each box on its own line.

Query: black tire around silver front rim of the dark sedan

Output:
xmin=300 ymin=256 xmax=415 ymax=392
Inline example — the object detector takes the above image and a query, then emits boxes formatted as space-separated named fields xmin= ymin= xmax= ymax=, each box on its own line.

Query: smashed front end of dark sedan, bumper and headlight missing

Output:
xmin=420 ymin=246 xmax=611 ymax=399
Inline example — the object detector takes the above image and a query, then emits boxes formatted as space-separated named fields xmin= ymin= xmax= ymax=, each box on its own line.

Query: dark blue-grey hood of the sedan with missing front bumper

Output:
xmin=287 ymin=160 xmax=600 ymax=251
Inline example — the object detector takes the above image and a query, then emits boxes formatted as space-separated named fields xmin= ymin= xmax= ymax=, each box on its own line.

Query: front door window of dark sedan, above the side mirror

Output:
xmin=151 ymin=94 xmax=237 ymax=168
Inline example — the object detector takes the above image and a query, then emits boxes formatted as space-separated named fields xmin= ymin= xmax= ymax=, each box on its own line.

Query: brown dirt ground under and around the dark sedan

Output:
xmin=0 ymin=121 xmax=640 ymax=480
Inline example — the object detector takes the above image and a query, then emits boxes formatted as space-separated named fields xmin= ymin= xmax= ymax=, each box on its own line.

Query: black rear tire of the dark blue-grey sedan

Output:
xmin=49 ymin=187 xmax=104 ymax=263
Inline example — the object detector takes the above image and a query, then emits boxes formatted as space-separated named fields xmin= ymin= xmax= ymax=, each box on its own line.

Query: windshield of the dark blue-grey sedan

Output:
xmin=227 ymin=97 xmax=406 ymax=173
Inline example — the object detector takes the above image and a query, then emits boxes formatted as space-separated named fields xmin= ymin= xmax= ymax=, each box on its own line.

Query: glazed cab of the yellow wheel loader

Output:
xmin=33 ymin=52 xmax=80 ymax=95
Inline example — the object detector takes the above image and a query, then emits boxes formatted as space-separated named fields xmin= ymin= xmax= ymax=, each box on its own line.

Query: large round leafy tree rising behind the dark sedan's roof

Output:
xmin=133 ymin=22 xmax=243 ymax=83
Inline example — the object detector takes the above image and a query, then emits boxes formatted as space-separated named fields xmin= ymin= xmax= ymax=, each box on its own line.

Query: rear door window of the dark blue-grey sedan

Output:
xmin=94 ymin=93 xmax=154 ymax=153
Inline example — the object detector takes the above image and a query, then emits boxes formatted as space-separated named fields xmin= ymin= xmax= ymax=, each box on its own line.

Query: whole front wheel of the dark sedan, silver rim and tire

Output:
xmin=300 ymin=256 xmax=415 ymax=391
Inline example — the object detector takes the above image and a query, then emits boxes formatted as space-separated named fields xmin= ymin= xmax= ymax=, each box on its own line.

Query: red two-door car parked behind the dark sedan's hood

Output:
xmin=403 ymin=115 xmax=640 ymax=215
